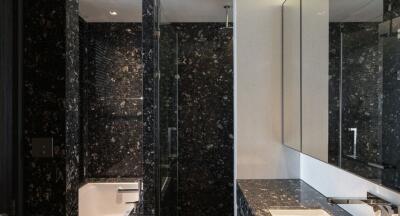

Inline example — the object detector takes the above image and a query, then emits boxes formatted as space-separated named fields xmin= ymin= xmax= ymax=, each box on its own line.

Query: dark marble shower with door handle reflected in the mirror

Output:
xmin=338 ymin=18 xmax=400 ymax=186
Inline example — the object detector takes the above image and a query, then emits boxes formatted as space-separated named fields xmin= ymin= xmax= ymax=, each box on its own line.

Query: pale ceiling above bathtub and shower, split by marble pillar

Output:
xmin=79 ymin=0 xmax=233 ymax=22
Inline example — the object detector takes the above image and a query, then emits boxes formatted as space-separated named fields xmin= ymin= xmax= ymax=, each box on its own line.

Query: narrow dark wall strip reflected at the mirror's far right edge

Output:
xmin=381 ymin=1 xmax=400 ymax=190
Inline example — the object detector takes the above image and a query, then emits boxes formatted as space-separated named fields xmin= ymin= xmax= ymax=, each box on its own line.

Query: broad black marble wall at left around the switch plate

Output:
xmin=23 ymin=0 xmax=80 ymax=215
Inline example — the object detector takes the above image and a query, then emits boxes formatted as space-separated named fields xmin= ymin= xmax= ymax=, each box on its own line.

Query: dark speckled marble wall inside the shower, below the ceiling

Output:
xmin=160 ymin=23 xmax=233 ymax=215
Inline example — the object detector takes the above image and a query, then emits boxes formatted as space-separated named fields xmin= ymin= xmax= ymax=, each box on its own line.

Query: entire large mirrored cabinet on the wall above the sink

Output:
xmin=282 ymin=0 xmax=400 ymax=191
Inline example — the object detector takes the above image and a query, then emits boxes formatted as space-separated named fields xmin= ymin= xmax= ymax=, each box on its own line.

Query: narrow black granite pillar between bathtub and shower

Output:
xmin=141 ymin=0 xmax=158 ymax=215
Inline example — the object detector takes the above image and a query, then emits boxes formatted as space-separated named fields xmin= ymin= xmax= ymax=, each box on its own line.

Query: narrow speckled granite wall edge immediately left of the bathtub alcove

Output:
xmin=65 ymin=0 xmax=83 ymax=216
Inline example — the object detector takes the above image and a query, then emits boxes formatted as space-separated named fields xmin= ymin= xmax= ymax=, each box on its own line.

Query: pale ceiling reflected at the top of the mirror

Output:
xmin=329 ymin=0 xmax=383 ymax=22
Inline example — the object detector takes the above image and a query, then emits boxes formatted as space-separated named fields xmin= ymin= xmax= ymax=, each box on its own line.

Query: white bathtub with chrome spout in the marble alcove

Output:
xmin=79 ymin=182 xmax=139 ymax=216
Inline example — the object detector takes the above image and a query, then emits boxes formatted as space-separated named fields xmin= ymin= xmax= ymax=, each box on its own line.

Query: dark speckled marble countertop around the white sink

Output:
xmin=237 ymin=179 xmax=351 ymax=216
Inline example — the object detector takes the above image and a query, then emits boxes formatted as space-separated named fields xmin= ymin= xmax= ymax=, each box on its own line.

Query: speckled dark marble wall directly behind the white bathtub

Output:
xmin=80 ymin=20 xmax=143 ymax=178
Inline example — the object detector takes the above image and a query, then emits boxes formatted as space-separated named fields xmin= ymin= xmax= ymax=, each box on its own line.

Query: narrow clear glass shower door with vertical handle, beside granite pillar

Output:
xmin=159 ymin=25 xmax=179 ymax=216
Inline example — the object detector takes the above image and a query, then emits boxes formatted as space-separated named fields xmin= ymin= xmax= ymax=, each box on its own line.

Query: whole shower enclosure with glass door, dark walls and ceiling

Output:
xmin=155 ymin=0 xmax=233 ymax=216
